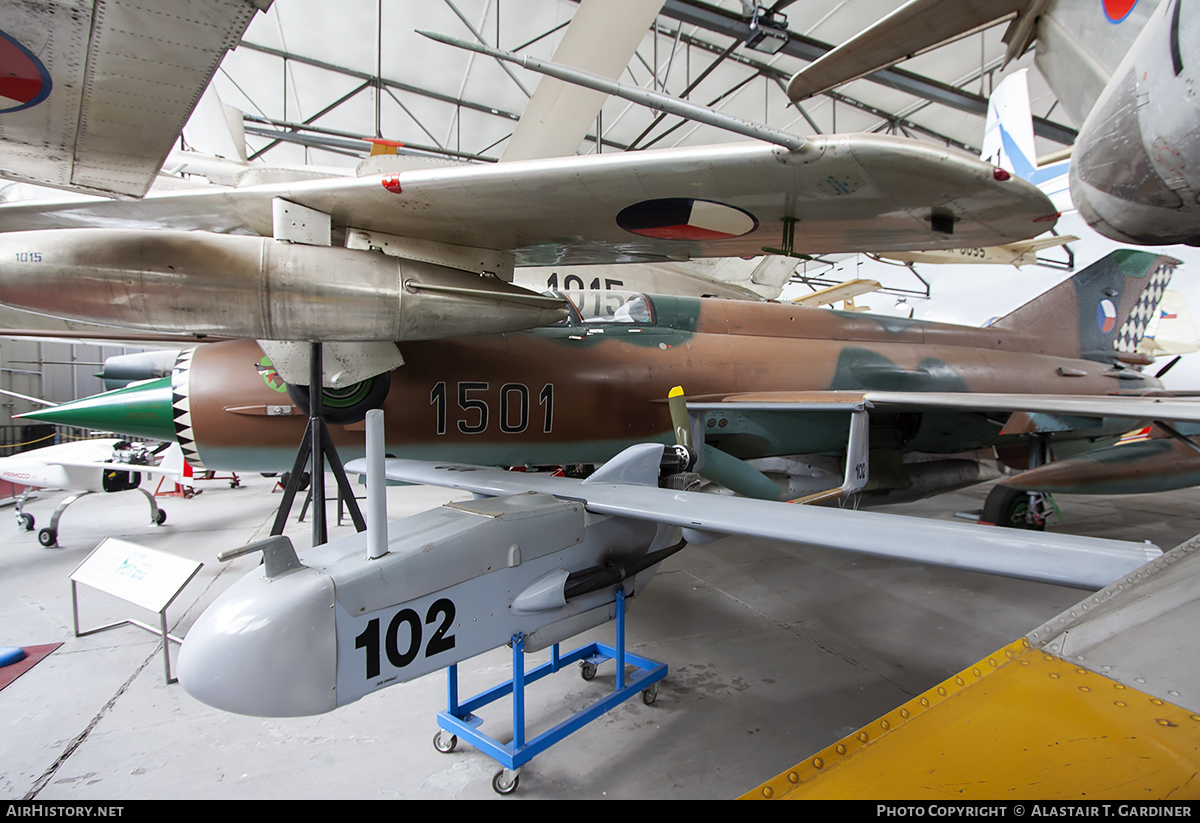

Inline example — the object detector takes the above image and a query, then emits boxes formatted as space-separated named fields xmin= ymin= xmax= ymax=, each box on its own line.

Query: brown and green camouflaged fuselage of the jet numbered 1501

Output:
xmin=175 ymin=294 xmax=1158 ymax=471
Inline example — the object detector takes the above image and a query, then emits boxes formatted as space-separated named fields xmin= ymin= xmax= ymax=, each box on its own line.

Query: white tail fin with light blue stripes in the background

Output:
xmin=979 ymin=68 xmax=1075 ymax=211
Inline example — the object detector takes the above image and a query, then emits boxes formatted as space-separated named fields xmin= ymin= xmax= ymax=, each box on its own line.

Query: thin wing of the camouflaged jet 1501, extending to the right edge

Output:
xmin=688 ymin=391 xmax=1200 ymax=422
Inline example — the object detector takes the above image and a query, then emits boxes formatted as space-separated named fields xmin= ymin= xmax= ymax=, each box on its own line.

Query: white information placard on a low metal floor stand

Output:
xmin=71 ymin=537 xmax=204 ymax=684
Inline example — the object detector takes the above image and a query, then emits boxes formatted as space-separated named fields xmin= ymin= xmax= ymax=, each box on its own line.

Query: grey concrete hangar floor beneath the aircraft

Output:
xmin=0 ymin=475 xmax=1200 ymax=801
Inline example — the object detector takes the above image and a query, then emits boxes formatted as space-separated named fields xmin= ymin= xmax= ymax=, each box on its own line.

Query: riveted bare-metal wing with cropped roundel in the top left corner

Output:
xmin=0 ymin=0 xmax=271 ymax=197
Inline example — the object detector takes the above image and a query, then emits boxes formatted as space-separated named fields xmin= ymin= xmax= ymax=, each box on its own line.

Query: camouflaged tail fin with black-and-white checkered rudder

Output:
xmin=991 ymin=248 xmax=1180 ymax=362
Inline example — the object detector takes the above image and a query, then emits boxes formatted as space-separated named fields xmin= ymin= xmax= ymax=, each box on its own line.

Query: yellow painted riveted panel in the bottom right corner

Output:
xmin=743 ymin=639 xmax=1200 ymax=800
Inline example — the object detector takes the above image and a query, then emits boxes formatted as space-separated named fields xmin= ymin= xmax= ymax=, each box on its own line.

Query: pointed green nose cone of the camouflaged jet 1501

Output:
xmin=16 ymin=377 xmax=175 ymax=443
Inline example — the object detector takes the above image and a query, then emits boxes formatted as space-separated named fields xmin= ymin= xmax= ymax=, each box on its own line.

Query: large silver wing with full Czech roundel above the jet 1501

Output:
xmin=0 ymin=134 xmax=1056 ymax=265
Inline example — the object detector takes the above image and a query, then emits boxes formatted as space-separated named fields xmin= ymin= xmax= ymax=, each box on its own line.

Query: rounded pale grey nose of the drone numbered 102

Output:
xmin=178 ymin=569 xmax=337 ymax=717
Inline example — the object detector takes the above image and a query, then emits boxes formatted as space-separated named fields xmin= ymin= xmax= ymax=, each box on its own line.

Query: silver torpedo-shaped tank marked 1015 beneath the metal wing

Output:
xmin=0 ymin=229 xmax=566 ymax=341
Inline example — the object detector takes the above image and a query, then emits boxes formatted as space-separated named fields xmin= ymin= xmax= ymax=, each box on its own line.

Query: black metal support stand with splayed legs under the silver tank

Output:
xmin=271 ymin=343 xmax=367 ymax=546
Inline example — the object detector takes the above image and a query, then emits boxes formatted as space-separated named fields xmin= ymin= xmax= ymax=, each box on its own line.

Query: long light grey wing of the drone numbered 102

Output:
xmin=346 ymin=444 xmax=1162 ymax=589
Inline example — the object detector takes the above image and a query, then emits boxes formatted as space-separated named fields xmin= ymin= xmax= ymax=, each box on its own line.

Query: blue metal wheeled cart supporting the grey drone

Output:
xmin=433 ymin=589 xmax=667 ymax=794
